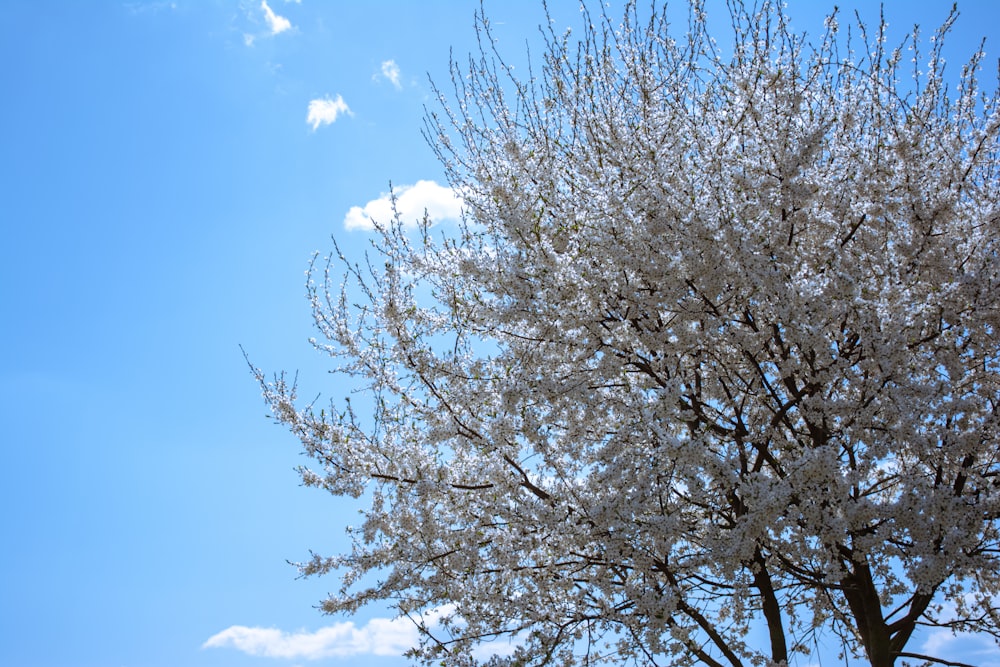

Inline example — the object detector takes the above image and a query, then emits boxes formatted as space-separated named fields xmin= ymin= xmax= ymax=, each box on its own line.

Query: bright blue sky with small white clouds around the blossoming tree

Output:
xmin=0 ymin=0 xmax=1000 ymax=667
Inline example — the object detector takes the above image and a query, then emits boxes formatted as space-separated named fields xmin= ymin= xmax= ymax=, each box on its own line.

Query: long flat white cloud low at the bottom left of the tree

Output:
xmin=202 ymin=618 xmax=420 ymax=660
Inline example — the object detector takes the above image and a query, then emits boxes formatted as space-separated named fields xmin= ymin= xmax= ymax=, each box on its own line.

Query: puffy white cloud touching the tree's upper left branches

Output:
xmin=344 ymin=181 xmax=462 ymax=229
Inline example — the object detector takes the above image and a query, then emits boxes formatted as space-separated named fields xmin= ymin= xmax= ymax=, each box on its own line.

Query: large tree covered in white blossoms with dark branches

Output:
xmin=256 ymin=1 xmax=1000 ymax=667
